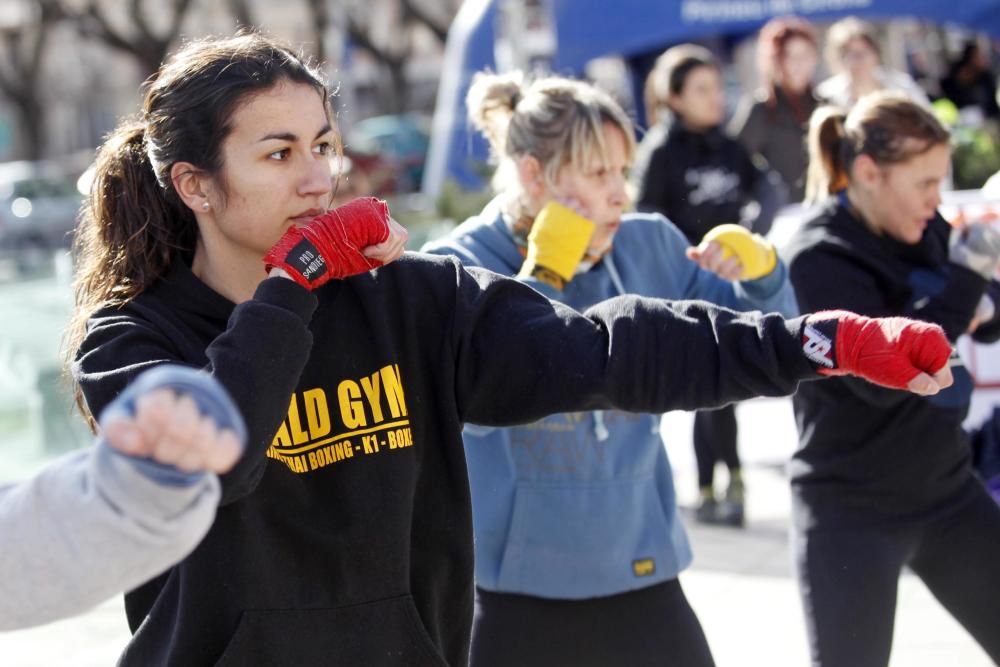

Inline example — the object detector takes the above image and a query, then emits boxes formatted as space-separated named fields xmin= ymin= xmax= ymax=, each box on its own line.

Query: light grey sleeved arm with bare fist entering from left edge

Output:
xmin=0 ymin=367 xmax=245 ymax=630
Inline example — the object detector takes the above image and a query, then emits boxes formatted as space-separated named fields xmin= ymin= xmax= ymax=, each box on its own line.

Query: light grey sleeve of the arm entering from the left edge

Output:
xmin=0 ymin=443 xmax=219 ymax=631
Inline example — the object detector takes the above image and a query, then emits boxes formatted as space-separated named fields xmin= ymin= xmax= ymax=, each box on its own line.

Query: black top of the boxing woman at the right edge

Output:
xmin=785 ymin=198 xmax=1000 ymax=525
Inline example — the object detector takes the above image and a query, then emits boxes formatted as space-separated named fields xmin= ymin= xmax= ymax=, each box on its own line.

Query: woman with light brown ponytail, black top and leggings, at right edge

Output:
xmin=786 ymin=93 xmax=1000 ymax=666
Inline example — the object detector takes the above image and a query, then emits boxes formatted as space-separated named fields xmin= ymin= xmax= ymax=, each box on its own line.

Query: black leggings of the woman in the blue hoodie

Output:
xmin=469 ymin=579 xmax=715 ymax=667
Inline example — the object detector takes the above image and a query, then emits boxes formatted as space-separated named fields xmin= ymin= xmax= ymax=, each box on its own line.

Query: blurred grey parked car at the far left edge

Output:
xmin=0 ymin=161 xmax=83 ymax=268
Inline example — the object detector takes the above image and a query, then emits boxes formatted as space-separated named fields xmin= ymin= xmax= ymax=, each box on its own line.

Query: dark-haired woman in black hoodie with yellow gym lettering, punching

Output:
xmin=71 ymin=28 xmax=947 ymax=667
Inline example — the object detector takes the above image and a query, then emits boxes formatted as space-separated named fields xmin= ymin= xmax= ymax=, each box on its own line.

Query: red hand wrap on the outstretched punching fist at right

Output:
xmin=802 ymin=310 xmax=951 ymax=389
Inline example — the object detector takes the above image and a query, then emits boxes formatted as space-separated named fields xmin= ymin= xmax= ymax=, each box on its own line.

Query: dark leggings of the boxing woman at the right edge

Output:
xmin=793 ymin=479 xmax=1000 ymax=667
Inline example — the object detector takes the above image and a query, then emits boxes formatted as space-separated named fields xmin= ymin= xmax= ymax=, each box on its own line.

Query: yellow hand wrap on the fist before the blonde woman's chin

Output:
xmin=517 ymin=202 xmax=595 ymax=289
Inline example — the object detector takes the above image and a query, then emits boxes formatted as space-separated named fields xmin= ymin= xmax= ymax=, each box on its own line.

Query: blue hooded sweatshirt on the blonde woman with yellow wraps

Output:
xmin=423 ymin=200 xmax=798 ymax=599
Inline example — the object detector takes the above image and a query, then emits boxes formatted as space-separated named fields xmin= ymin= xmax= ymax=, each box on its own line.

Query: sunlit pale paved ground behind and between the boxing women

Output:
xmin=0 ymin=400 xmax=991 ymax=667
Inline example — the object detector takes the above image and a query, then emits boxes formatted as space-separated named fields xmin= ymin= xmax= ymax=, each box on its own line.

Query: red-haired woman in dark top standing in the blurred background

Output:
xmin=729 ymin=16 xmax=819 ymax=202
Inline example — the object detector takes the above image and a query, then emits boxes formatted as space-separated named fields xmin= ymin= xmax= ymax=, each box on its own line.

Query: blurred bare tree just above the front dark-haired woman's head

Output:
xmin=70 ymin=0 xmax=196 ymax=78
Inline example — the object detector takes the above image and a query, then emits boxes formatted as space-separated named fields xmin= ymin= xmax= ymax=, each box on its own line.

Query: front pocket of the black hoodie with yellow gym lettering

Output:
xmin=216 ymin=595 xmax=447 ymax=667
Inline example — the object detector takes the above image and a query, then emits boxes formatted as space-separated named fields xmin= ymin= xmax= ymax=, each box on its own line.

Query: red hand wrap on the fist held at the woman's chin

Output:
xmin=264 ymin=197 xmax=389 ymax=289
